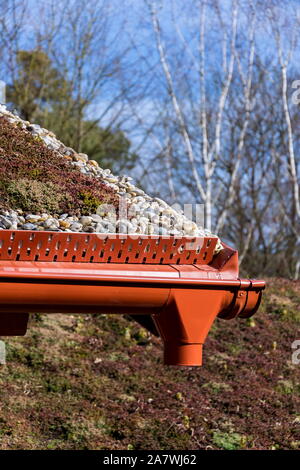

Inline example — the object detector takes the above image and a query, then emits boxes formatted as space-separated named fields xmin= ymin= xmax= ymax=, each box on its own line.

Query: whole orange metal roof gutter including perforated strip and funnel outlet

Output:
xmin=0 ymin=231 xmax=265 ymax=366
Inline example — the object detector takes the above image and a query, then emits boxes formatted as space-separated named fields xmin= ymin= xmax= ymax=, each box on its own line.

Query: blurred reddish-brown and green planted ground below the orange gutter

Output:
xmin=0 ymin=279 xmax=300 ymax=449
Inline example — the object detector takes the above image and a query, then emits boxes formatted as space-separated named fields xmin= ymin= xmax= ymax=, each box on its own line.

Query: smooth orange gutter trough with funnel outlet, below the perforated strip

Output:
xmin=0 ymin=234 xmax=265 ymax=366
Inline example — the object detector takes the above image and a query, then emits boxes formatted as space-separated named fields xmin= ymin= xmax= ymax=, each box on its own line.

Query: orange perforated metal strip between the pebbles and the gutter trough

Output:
xmin=0 ymin=230 xmax=217 ymax=264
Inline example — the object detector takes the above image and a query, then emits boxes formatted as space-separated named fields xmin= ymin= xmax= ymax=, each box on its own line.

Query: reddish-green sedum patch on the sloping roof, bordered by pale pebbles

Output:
xmin=0 ymin=117 xmax=118 ymax=215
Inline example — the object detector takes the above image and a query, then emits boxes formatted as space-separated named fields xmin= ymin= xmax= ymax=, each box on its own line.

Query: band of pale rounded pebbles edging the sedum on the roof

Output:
xmin=0 ymin=105 xmax=222 ymax=253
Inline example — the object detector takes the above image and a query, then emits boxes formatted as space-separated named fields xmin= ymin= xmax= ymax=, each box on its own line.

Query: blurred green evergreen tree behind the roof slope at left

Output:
xmin=7 ymin=49 xmax=137 ymax=172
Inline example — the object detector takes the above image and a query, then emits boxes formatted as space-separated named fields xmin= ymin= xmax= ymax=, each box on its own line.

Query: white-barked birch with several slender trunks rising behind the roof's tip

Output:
xmin=135 ymin=0 xmax=256 ymax=232
